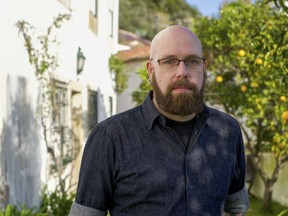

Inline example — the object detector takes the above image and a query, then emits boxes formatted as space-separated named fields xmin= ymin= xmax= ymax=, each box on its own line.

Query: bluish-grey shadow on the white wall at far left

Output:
xmin=0 ymin=75 xmax=42 ymax=208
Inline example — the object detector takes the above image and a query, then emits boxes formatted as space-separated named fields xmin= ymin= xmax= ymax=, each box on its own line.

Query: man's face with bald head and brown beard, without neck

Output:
xmin=147 ymin=27 xmax=206 ymax=116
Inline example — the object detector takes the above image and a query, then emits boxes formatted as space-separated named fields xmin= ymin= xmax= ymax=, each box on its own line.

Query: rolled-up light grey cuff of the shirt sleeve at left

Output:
xmin=68 ymin=202 xmax=107 ymax=216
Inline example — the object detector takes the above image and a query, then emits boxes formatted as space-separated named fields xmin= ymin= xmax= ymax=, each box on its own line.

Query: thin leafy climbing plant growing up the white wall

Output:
xmin=16 ymin=14 xmax=70 ymax=194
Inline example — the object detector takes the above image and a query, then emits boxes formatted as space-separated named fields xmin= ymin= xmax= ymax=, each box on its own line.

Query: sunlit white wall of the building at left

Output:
xmin=0 ymin=0 xmax=119 ymax=207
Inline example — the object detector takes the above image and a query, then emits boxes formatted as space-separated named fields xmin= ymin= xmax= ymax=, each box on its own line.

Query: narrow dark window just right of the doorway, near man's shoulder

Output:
xmin=88 ymin=90 xmax=98 ymax=131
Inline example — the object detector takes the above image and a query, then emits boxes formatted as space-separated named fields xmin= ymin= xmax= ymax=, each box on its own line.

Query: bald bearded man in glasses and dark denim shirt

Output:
xmin=70 ymin=25 xmax=249 ymax=216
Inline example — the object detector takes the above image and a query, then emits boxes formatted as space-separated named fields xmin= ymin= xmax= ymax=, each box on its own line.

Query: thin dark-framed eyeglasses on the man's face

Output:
xmin=151 ymin=58 xmax=206 ymax=70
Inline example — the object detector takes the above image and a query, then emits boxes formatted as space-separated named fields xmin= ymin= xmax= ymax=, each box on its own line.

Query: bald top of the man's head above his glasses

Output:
xmin=150 ymin=25 xmax=202 ymax=59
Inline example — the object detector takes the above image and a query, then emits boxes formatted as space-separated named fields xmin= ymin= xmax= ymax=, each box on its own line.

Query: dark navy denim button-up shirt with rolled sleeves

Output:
xmin=70 ymin=92 xmax=248 ymax=216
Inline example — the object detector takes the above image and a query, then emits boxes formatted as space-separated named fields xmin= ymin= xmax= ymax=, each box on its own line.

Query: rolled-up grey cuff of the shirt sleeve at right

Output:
xmin=224 ymin=187 xmax=249 ymax=215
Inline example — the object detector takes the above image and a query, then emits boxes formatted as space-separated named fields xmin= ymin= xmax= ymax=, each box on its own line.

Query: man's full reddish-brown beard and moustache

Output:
xmin=151 ymin=73 xmax=205 ymax=115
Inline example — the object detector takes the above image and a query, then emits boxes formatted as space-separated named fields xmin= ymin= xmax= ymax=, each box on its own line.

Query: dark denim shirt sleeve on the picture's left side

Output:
xmin=72 ymin=124 xmax=115 ymax=215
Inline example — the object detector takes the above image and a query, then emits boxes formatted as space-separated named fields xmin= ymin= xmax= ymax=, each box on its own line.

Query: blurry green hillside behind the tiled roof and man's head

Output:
xmin=119 ymin=0 xmax=200 ymax=39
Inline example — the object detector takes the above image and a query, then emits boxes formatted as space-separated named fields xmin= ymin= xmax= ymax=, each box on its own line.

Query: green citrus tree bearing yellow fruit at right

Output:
xmin=193 ymin=1 xmax=288 ymax=207
